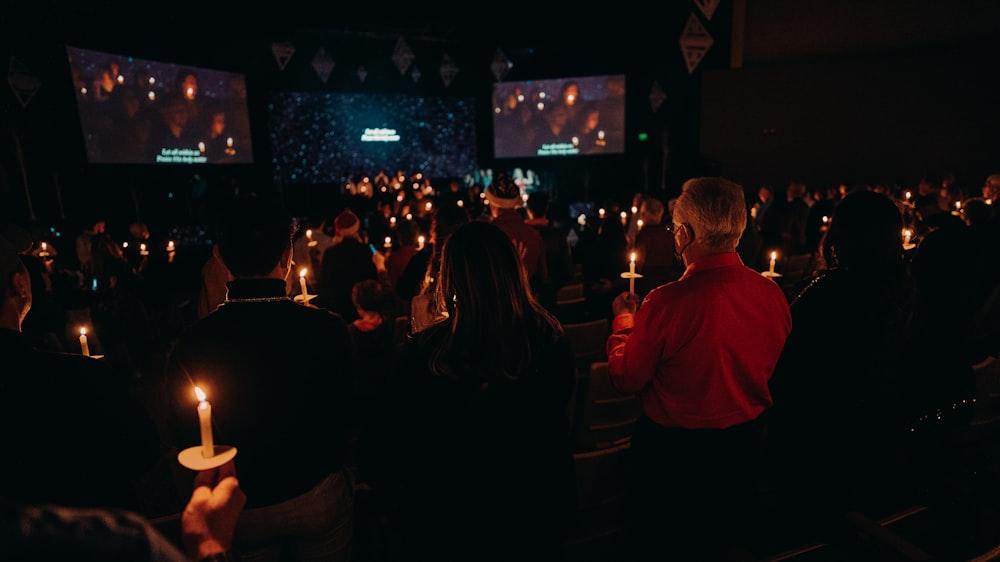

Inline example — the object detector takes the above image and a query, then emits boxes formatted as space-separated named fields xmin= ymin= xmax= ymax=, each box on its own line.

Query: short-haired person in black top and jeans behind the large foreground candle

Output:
xmin=161 ymin=190 xmax=356 ymax=561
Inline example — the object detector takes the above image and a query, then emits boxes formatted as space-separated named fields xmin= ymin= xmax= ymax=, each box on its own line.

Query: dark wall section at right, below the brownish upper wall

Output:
xmin=701 ymin=45 xmax=1000 ymax=187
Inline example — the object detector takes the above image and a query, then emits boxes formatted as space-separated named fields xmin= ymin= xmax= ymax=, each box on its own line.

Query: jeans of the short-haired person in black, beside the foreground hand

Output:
xmin=233 ymin=470 xmax=354 ymax=562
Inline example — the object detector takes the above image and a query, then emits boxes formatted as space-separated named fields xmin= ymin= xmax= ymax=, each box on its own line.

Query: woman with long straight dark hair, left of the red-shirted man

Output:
xmin=361 ymin=221 xmax=576 ymax=560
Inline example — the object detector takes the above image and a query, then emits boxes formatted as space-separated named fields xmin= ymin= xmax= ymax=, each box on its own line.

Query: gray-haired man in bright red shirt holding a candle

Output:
xmin=607 ymin=178 xmax=791 ymax=560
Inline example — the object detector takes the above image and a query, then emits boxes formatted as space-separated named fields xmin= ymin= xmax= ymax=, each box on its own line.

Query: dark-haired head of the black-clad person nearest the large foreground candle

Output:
xmin=219 ymin=194 xmax=294 ymax=277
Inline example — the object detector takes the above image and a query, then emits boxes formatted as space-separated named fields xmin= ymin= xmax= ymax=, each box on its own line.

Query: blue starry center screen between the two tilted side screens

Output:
xmin=268 ymin=92 xmax=477 ymax=184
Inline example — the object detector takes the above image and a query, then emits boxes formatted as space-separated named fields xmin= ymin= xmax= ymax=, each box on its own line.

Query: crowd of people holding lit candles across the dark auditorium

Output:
xmin=0 ymin=168 xmax=1000 ymax=561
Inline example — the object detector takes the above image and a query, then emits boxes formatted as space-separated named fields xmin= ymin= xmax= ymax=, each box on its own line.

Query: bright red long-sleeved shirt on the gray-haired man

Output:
xmin=607 ymin=252 xmax=792 ymax=428
